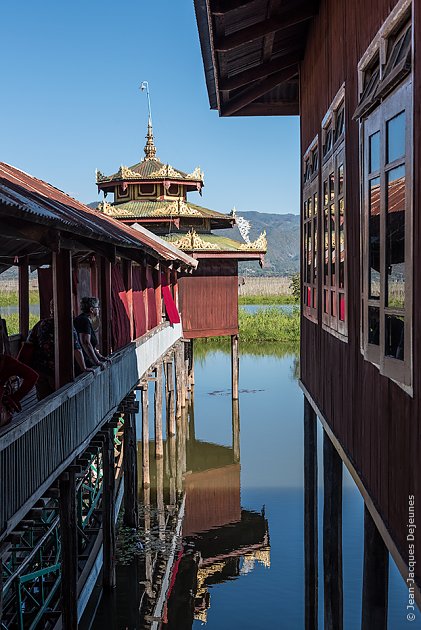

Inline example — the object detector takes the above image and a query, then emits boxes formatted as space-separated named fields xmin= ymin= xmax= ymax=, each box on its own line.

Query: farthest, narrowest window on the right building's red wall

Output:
xmin=302 ymin=138 xmax=319 ymax=321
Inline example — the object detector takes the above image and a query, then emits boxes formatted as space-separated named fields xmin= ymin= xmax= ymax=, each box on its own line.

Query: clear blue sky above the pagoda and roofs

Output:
xmin=0 ymin=0 xmax=299 ymax=213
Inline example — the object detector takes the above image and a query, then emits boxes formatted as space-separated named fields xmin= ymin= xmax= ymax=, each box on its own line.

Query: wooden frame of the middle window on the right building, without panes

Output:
xmin=319 ymin=85 xmax=348 ymax=342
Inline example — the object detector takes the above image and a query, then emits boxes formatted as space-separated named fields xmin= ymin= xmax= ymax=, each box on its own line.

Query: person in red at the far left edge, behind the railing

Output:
xmin=0 ymin=352 xmax=38 ymax=427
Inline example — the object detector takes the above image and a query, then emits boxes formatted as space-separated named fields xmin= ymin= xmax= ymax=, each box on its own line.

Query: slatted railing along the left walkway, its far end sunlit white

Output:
xmin=0 ymin=322 xmax=182 ymax=540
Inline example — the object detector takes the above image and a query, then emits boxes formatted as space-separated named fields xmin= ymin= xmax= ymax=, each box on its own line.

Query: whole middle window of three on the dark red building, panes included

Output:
xmin=320 ymin=88 xmax=348 ymax=339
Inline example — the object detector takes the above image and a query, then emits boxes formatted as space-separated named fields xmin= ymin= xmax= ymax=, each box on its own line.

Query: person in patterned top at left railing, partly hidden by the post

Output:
xmin=28 ymin=300 xmax=93 ymax=400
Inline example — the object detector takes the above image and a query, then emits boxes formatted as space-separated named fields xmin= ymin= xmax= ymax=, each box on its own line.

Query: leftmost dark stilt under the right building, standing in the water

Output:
xmin=304 ymin=396 xmax=318 ymax=630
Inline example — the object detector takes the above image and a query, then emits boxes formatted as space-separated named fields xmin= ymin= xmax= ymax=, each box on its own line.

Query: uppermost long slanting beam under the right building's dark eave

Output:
xmin=215 ymin=6 xmax=316 ymax=52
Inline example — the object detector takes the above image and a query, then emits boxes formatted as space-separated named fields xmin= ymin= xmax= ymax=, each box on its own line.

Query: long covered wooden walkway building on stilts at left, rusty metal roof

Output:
xmin=0 ymin=163 xmax=197 ymax=630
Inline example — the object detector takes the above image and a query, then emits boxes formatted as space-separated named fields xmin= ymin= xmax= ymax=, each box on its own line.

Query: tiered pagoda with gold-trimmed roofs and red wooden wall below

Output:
xmin=96 ymin=118 xmax=266 ymax=366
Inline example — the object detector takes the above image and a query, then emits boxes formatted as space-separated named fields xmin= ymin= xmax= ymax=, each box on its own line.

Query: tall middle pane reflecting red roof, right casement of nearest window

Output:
xmin=386 ymin=166 xmax=405 ymax=308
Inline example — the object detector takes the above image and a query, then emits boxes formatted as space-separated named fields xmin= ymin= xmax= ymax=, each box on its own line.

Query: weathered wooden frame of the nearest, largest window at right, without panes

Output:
xmin=361 ymin=77 xmax=413 ymax=393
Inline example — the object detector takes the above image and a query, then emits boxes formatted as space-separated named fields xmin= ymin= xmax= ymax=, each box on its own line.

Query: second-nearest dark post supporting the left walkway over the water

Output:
xmin=102 ymin=429 xmax=116 ymax=590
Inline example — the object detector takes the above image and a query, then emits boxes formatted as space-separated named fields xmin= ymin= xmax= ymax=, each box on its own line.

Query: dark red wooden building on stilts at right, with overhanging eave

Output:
xmin=195 ymin=0 xmax=421 ymax=628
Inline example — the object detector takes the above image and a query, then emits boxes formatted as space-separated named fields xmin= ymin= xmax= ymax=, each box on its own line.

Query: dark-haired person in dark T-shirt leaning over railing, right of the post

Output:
xmin=73 ymin=297 xmax=108 ymax=369
